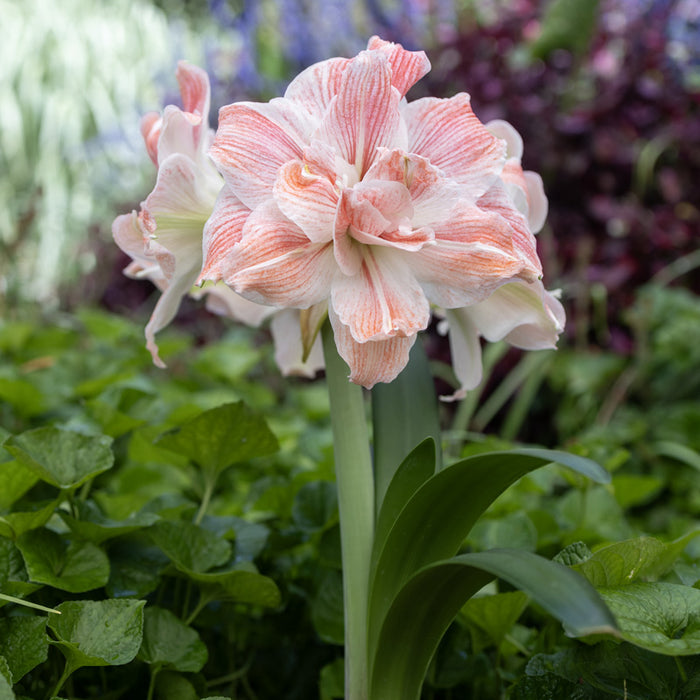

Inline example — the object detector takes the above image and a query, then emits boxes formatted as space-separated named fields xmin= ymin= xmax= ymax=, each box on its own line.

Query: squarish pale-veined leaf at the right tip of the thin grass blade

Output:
xmin=49 ymin=600 xmax=146 ymax=670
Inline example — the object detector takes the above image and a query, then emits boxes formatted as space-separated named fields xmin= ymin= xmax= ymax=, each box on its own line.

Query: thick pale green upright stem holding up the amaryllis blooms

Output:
xmin=322 ymin=323 xmax=374 ymax=700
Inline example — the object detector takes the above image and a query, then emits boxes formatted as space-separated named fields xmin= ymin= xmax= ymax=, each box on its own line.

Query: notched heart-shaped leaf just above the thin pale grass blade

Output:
xmin=17 ymin=528 xmax=109 ymax=593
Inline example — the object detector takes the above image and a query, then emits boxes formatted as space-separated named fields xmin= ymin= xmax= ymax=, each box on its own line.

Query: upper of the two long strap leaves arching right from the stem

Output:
xmin=368 ymin=449 xmax=609 ymax=657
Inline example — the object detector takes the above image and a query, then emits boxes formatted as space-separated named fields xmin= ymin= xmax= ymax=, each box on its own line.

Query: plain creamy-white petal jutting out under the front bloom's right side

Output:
xmin=469 ymin=281 xmax=566 ymax=350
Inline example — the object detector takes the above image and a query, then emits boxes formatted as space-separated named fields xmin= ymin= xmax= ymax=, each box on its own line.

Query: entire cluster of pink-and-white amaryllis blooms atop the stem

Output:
xmin=114 ymin=37 xmax=564 ymax=397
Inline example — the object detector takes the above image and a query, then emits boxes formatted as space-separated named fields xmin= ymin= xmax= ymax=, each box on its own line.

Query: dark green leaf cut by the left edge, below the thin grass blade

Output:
xmin=0 ymin=615 xmax=49 ymax=683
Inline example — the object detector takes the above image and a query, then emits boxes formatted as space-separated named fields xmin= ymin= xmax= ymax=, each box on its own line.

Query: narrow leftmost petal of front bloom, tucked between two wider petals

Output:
xmin=197 ymin=186 xmax=250 ymax=283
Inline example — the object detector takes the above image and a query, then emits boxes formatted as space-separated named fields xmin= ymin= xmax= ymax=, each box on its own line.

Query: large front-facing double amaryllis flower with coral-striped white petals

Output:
xmin=200 ymin=37 xmax=560 ymax=387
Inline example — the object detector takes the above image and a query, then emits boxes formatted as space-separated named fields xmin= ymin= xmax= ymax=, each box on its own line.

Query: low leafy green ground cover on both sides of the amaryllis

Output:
xmin=0 ymin=286 xmax=700 ymax=700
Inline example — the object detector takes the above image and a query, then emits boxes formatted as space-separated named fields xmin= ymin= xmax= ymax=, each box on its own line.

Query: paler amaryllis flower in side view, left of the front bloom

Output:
xmin=112 ymin=62 xmax=223 ymax=366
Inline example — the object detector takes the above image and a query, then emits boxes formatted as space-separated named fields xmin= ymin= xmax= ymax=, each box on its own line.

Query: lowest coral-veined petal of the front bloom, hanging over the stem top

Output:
xmin=328 ymin=307 xmax=417 ymax=389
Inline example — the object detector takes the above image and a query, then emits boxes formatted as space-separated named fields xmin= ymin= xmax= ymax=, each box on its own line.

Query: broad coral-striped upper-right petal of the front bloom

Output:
xmin=402 ymin=93 xmax=506 ymax=201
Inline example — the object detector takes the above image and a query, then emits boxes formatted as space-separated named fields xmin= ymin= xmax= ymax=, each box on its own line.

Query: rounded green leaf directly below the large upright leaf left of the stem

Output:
xmin=148 ymin=520 xmax=231 ymax=573
